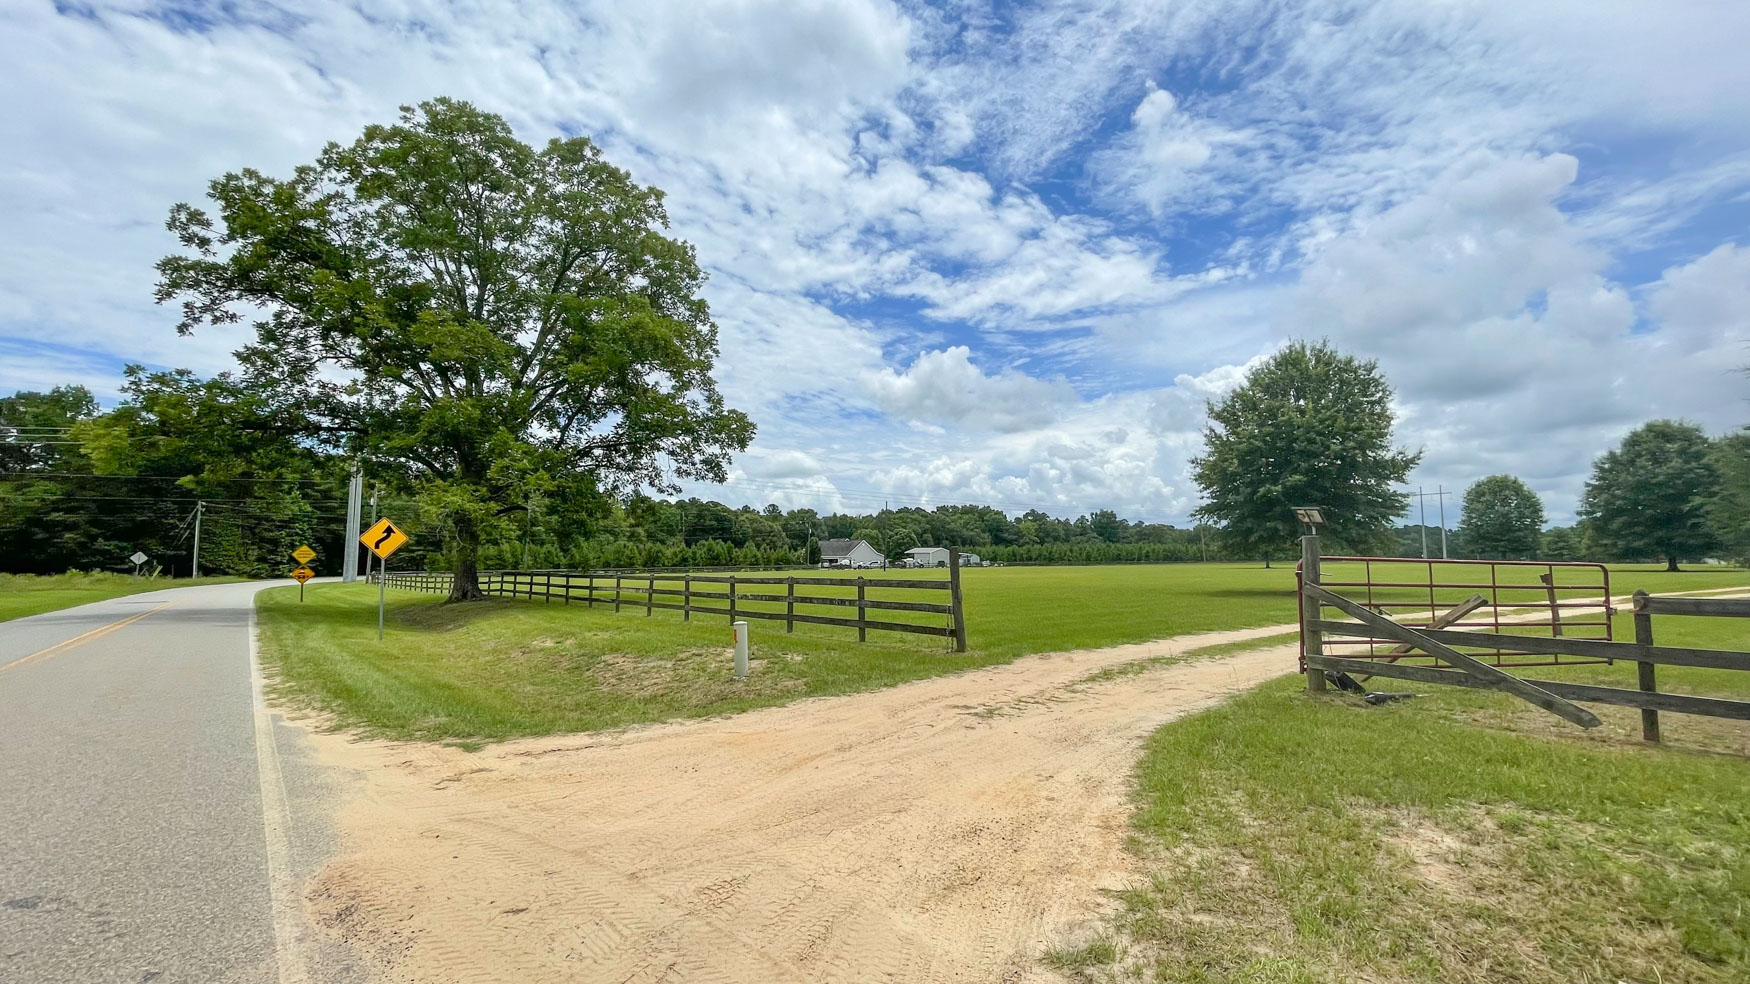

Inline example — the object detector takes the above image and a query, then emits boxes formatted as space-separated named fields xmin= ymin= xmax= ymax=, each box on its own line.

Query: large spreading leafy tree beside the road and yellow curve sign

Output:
xmin=158 ymin=98 xmax=754 ymax=601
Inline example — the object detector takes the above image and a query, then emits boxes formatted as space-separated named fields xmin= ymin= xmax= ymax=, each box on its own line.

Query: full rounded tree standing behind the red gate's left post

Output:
xmin=1192 ymin=341 xmax=1421 ymax=559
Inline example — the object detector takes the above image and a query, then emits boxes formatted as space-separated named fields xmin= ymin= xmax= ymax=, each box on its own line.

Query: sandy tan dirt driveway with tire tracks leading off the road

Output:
xmin=306 ymin=627 xmax=1295 ymax=984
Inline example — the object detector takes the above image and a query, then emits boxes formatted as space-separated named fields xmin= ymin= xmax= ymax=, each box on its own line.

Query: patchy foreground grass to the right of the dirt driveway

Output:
xmin=1052 ymin=615 xmax=1750 ymax=984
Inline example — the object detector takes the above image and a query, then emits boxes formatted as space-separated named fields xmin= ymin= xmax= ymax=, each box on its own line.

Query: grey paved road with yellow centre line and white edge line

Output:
xmin=0 ymin=581 xmax=355 ymax=984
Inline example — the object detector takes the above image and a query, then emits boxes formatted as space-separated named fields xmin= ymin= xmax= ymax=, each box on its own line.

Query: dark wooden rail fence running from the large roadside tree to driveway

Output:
xmin=387 ymin=550 xmax=966 ymax=653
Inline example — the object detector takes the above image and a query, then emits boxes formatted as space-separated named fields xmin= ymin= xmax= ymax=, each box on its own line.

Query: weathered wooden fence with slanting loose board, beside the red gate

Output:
xmin=1300 ymin=536 xmax=1750 ymax=741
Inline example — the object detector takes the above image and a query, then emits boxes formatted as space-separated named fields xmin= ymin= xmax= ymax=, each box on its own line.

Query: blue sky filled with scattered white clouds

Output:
xmin=0 ymin=0 xmax=1750 ymax=522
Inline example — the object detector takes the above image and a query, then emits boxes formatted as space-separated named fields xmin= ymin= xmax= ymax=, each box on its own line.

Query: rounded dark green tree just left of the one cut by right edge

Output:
xmin=1580 ymin=420 xmax=1719 ymax=571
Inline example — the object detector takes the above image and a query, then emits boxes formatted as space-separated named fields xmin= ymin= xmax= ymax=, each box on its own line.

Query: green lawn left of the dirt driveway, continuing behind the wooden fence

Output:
xmin=257 ymin=564 xmax=1750 ymax=742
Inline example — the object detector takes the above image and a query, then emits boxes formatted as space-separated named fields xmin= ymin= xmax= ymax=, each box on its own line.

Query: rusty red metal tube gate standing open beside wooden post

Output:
xmin=1295 ymin=557 xmax=1615 ymax=672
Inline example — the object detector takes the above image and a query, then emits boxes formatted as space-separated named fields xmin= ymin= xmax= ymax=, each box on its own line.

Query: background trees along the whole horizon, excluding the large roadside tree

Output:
xmin=0 ymin=347 xmax=1750 ymax=576
